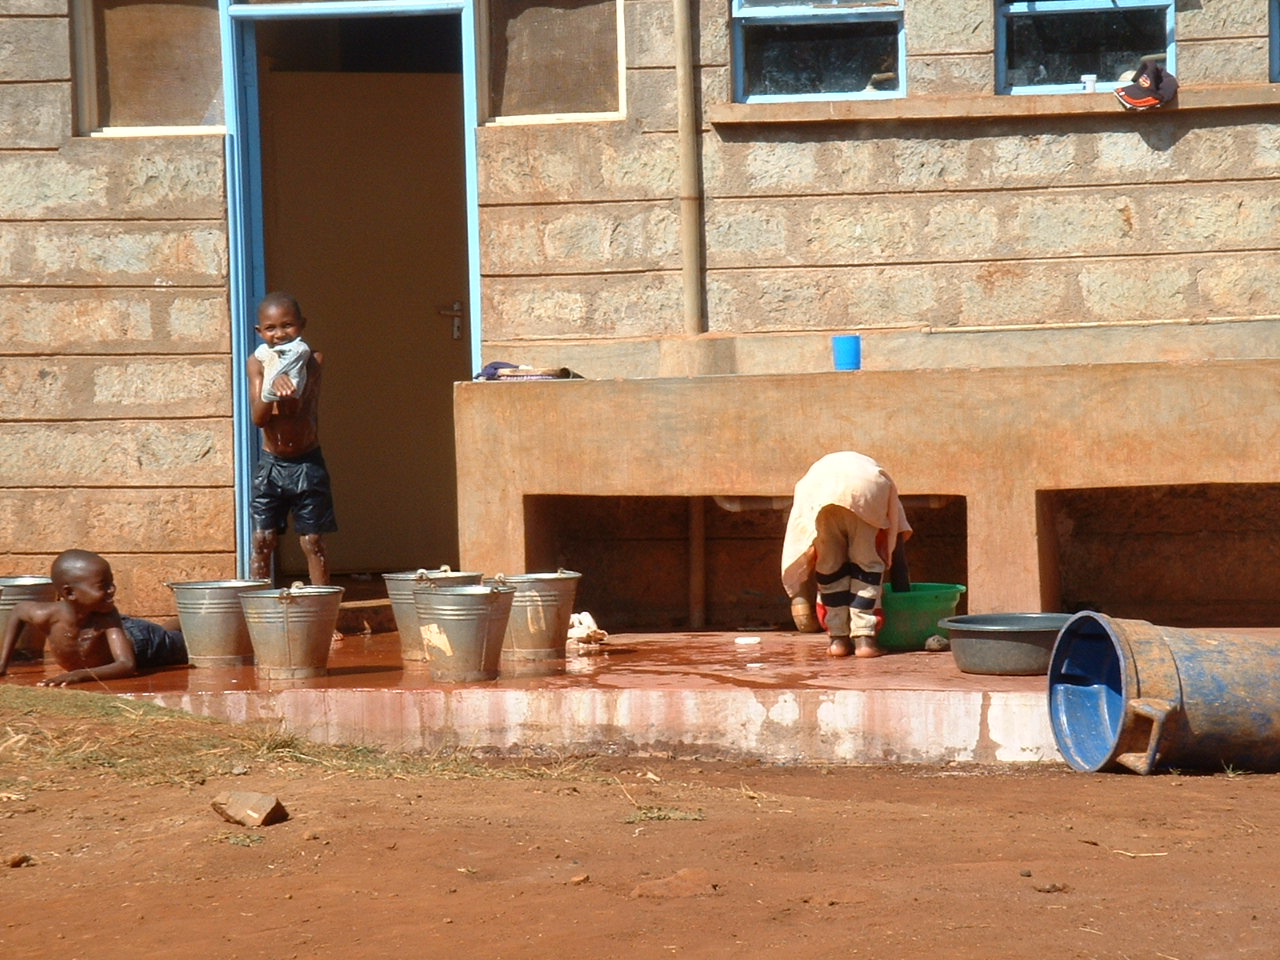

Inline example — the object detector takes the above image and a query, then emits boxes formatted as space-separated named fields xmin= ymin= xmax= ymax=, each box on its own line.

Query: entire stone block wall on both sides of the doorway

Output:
xmin=0 ymin=0 xmax=1280 ymax=616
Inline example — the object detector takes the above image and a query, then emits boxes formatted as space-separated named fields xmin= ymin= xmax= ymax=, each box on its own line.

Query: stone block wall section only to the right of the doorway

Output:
xmin=480 ymin=0 xmax=1280 ymax=376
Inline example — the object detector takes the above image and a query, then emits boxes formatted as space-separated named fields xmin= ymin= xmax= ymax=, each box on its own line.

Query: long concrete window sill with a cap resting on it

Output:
xmin=707 ymin=83 xmax=1280 ymax=124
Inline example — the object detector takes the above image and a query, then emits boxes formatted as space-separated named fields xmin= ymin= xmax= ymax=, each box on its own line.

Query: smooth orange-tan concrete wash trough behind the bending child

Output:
xmin=454 ymin=361 xmax=1280 ymax=613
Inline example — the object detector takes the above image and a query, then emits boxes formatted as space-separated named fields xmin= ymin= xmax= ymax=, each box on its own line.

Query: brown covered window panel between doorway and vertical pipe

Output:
xmin=489 ymin=0 xmax=621 ymax=116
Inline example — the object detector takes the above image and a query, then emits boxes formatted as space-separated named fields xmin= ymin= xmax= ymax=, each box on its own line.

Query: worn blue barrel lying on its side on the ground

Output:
xmin=1048 ymin=612 xmax=1280 ymax=773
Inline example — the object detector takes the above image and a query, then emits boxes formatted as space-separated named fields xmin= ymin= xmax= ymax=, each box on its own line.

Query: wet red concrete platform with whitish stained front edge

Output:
xmin=9 ymin=632 xmax=1061 ymax=764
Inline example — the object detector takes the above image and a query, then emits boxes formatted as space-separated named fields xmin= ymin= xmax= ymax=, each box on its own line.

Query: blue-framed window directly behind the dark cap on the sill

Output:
xmin=996 ymin=0 xmax=1176 ymax=93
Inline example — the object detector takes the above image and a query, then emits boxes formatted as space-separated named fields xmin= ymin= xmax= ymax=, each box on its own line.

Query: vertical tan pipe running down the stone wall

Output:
xmin=672 ymin=0 xmax=707 ymax=337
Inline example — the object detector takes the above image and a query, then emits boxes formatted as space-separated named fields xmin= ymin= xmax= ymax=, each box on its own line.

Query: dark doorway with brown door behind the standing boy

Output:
xmin=250 ymin=15 xmax=472 ymax=577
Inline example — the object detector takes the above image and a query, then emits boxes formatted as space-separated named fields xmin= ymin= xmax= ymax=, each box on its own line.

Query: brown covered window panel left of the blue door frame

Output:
xmin=81 ymin=0 xmax=223 ymax=127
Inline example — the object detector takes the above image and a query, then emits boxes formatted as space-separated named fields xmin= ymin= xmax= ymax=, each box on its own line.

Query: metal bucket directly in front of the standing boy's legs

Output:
xmin=239 ymin=584 xmax=343 ymax=680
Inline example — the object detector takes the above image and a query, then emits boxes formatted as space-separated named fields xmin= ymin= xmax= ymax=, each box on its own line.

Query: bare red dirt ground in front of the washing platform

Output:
xmin=0 ymin=704 xmax=1280 ymax=960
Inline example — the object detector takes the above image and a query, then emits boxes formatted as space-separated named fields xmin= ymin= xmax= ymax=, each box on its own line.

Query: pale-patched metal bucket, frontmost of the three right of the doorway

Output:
xmin=413 ymin=580 xmax=516 ymax=684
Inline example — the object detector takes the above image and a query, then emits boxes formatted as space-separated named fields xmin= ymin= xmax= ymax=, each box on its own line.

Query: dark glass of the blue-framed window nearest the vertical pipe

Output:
xmin=742 ymin=20 xmax=899 ymax=96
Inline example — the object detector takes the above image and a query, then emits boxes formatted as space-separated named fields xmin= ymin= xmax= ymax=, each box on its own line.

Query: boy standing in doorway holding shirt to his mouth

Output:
xmin=246 ymin=292 xmax=338 ymax=586
